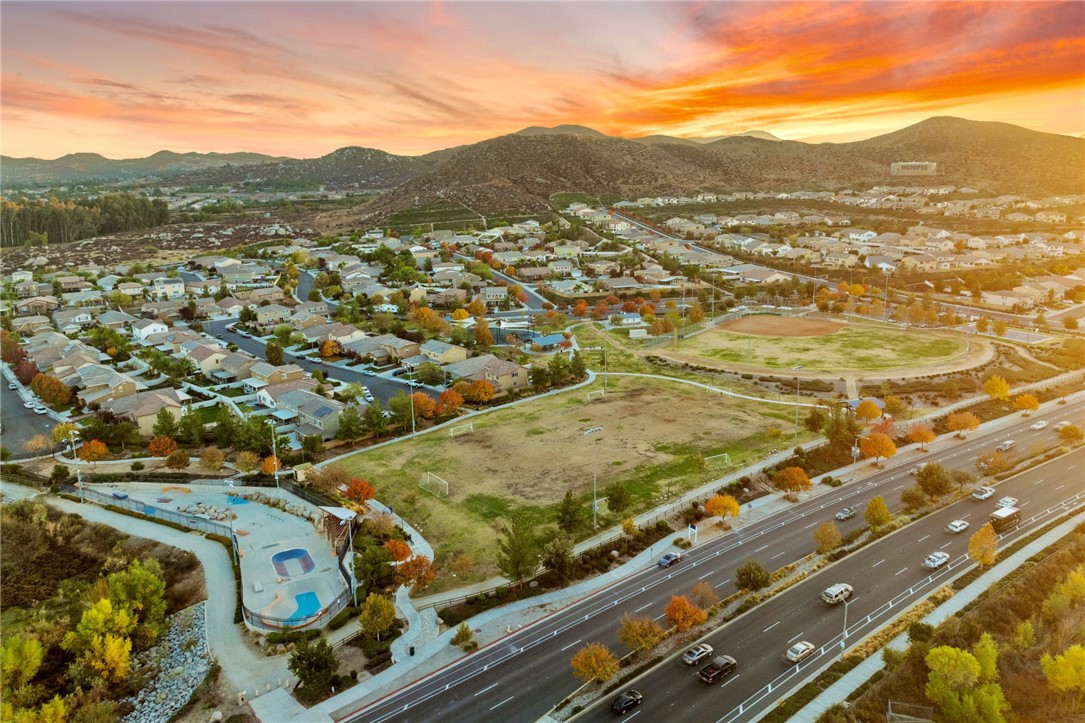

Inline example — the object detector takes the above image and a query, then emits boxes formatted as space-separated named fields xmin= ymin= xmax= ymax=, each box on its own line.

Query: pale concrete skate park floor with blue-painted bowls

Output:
xmin=88 ymin=483 xmax=347 ymax=629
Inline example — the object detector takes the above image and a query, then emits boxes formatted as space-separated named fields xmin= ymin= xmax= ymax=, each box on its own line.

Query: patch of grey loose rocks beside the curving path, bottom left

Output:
xmin=124 ymin=603 xmax=212 ymax=723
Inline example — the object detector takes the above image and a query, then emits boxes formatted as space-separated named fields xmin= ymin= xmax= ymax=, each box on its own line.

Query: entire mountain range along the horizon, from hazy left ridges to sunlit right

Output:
xmin=0 ymin=116 xmax=1085 ymax=219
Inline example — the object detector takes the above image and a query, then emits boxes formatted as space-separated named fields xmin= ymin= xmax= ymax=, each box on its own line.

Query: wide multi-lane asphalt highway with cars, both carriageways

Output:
xmin=349 ymin=401 xmax=1083 ymax=721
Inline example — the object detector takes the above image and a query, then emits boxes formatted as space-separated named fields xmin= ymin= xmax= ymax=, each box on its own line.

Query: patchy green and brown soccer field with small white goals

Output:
xmin=342 ymin=377 xmax=802 ymax=586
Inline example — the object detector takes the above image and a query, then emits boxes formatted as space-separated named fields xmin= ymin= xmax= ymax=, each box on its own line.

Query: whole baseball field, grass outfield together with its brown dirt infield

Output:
xmin=677 ymin=314 xmax=967 ymax=372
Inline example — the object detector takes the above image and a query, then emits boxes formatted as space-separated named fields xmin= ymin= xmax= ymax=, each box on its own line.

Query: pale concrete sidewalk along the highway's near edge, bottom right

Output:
xmin=791 ymin=513 xmax=1085 ymax=723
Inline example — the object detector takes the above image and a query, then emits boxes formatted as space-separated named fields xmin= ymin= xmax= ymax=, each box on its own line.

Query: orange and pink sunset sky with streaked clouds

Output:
xmin=0 ymin=0 xmax=1085 ymax=158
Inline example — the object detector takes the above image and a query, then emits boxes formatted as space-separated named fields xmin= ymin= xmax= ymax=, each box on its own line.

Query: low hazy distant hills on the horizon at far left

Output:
xmin=0 ymin=151 xmax=288 ymax=186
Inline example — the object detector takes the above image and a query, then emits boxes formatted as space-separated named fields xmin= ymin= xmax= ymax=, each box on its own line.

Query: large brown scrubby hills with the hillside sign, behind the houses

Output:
xmin=353 ymin=117 xmax=1085 ymax=222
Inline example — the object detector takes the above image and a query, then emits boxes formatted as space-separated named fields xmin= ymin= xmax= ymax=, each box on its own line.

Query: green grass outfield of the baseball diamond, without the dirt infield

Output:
xmin=677 ymin=324 xmax=965 ymax=372
